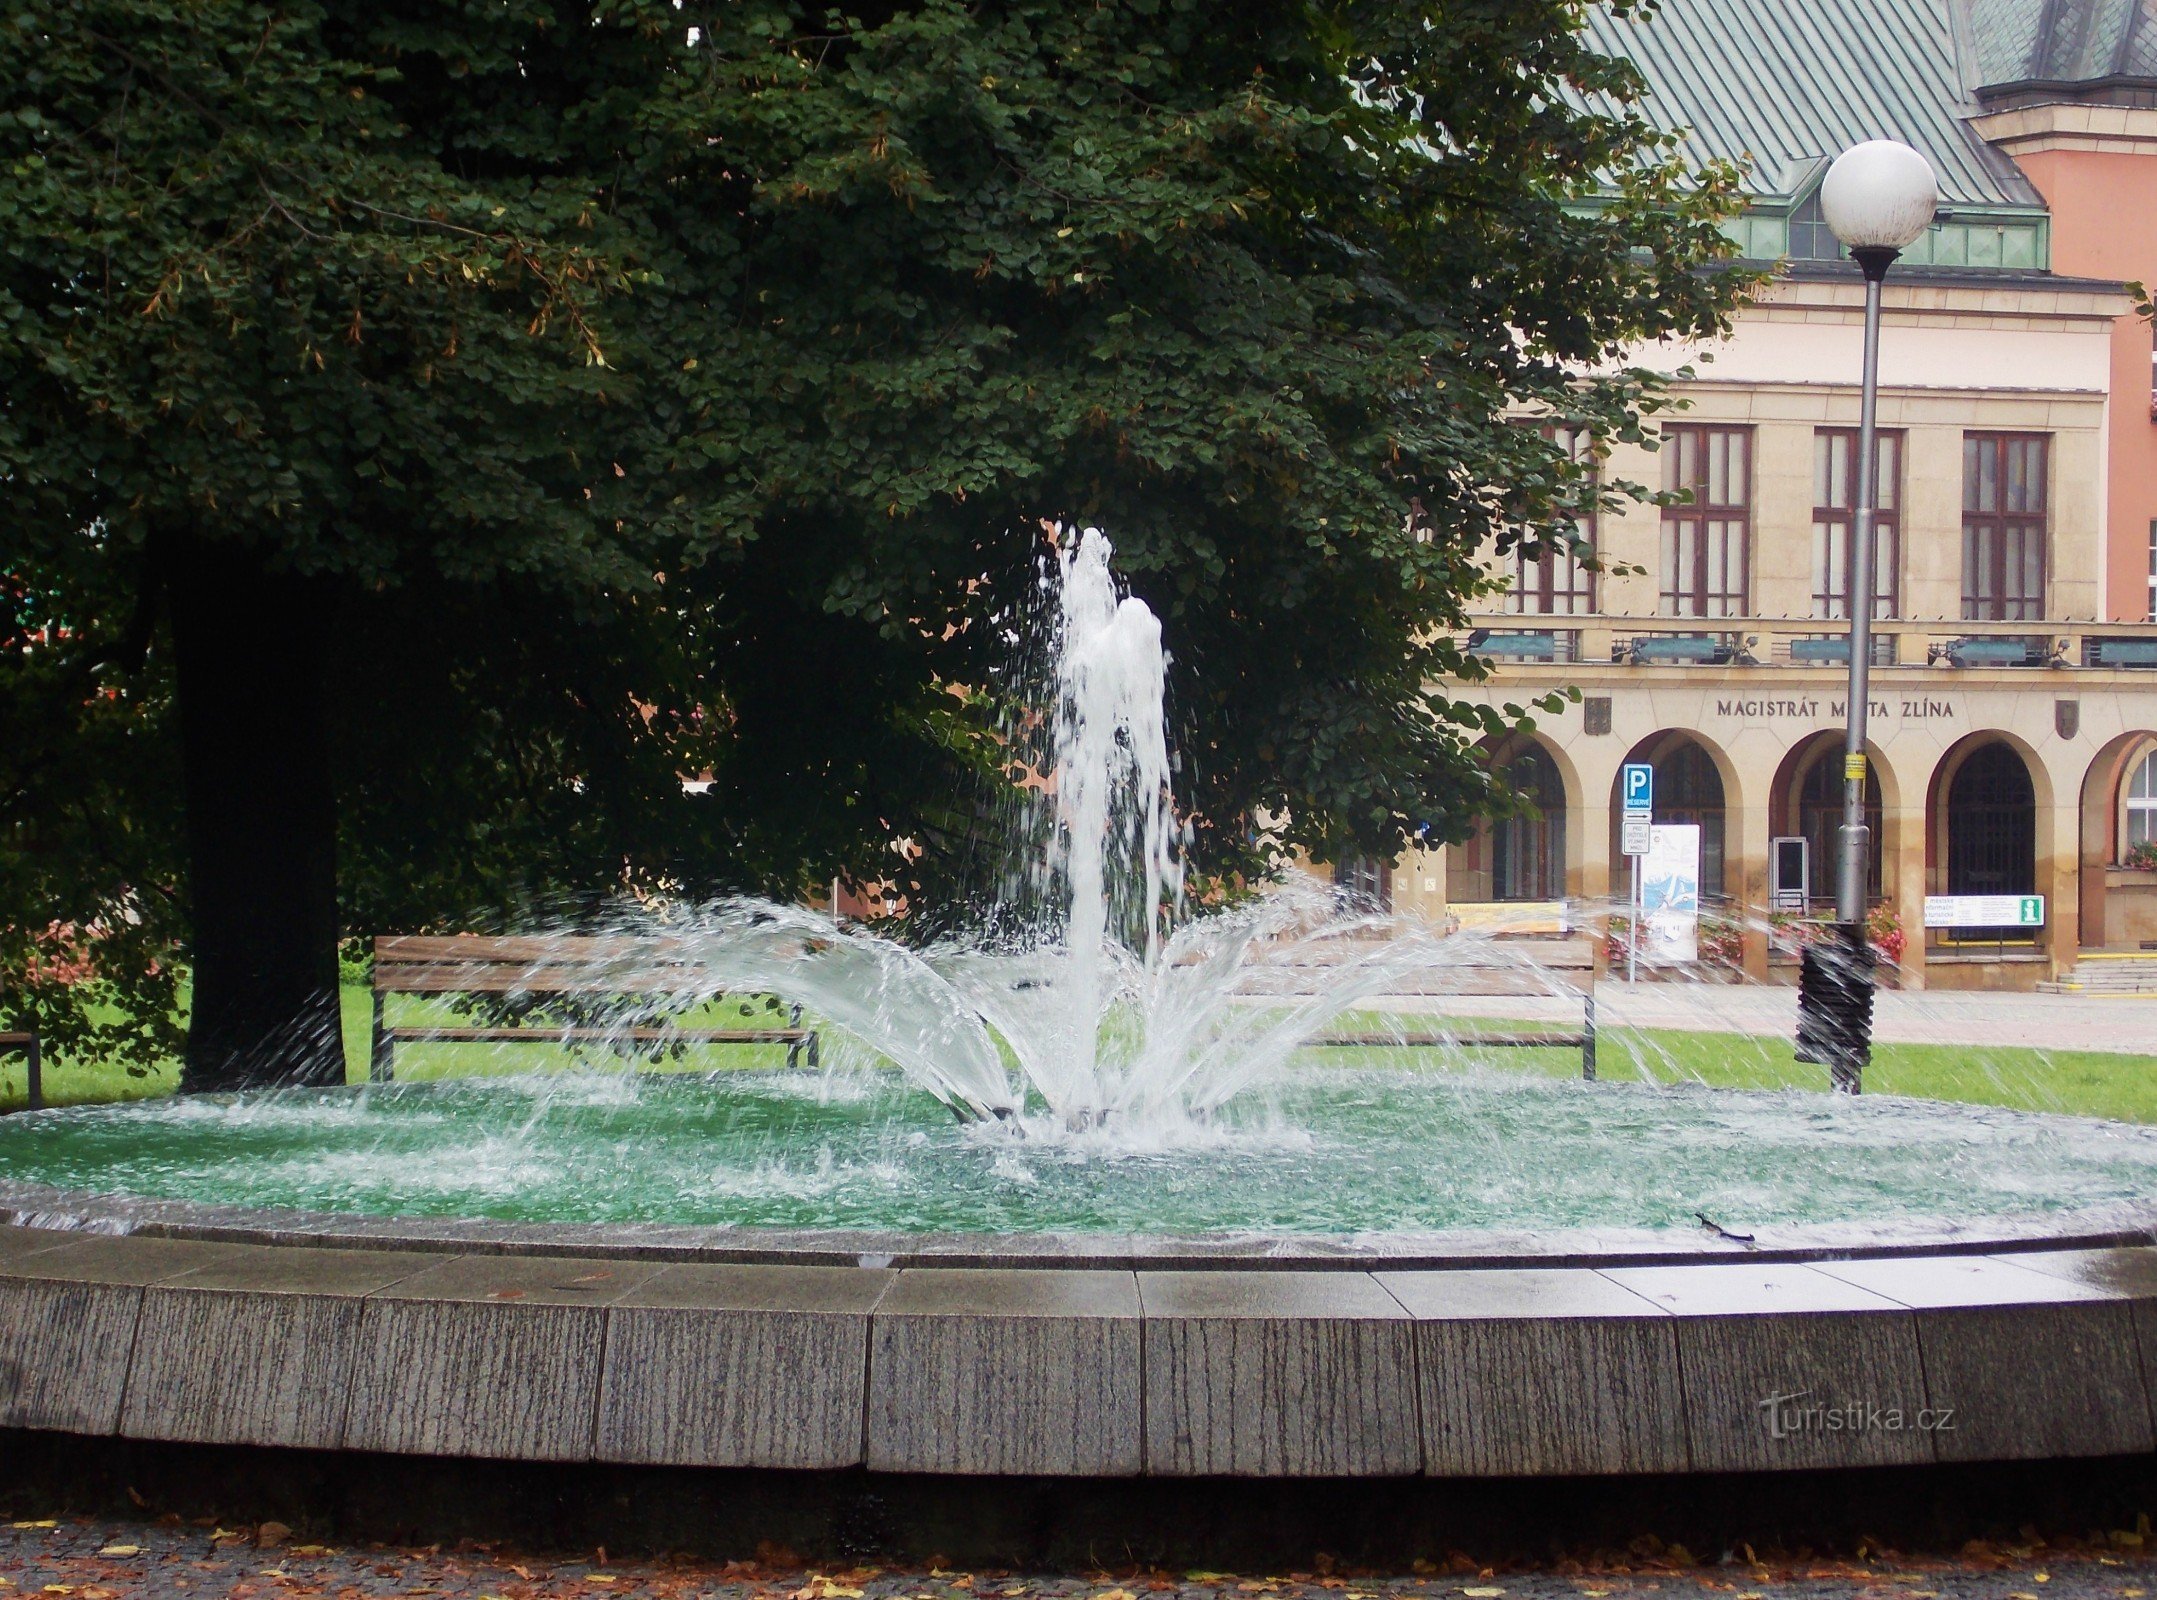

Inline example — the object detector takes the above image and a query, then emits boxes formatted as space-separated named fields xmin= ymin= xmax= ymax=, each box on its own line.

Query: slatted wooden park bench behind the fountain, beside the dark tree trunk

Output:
xmin=367 ymin=934 xmax=822 ymax=1082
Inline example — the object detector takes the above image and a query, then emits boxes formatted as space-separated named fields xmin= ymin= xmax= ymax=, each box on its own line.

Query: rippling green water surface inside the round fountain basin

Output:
xmin=0 ymin=1067 xmax=2157 ymax=1253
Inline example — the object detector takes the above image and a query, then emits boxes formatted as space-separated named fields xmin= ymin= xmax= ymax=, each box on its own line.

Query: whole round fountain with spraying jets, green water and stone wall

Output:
xmin=0 ymin=530 xmax=2157 ymax=1475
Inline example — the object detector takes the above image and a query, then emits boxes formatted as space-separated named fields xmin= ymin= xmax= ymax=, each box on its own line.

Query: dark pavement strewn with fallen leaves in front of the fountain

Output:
xmin=0 ymin=1518 xmax=2157 ymax=1600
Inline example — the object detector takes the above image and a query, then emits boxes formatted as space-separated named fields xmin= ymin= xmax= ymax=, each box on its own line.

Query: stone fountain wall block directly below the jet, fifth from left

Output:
xmin=865 ymin=1268 xmax=1143 ymax=1477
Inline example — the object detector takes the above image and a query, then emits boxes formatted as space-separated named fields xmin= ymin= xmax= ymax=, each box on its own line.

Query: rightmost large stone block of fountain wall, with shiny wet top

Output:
xmin=1818 ymin=1255 xmax=2153 ymax=1462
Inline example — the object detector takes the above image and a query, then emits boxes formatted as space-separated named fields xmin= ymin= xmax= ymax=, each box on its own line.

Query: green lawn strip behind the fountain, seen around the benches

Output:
xmin=0 ymin=983 xmax=2157 ymax=1121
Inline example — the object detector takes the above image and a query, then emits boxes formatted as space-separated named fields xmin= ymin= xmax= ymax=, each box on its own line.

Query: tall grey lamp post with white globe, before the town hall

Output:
xmin=1797 ymin=138 xmax=1939 ymax=1093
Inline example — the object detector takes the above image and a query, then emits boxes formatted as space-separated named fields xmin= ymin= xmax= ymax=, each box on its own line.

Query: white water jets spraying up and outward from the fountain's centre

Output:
xmin=582 ymin=528 xmax=1570 ymax=1145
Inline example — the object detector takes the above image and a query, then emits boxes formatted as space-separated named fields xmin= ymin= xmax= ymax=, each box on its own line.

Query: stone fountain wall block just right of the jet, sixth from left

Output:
xmin=1139 ymin=1270 xmax=1424 ymax=1477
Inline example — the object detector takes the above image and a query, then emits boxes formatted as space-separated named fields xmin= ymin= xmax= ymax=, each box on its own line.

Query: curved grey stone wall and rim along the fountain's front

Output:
xmin=0 ymin=1227 xmax=2157 ymax=1479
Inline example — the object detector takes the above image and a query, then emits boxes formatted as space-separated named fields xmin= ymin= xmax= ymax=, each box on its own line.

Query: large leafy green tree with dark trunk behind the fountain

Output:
xmin=0 ymin=0 xmax=1743 ymax=1087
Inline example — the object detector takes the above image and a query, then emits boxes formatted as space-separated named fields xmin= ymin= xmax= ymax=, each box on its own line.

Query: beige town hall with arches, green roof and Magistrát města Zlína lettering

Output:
xmin=1328 ymin=0 xmax=2157 ymax=988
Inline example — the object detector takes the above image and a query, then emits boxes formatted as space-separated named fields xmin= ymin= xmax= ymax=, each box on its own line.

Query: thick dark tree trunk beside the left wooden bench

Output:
xmin=166 ymin=539 xmax=345 ymax=1091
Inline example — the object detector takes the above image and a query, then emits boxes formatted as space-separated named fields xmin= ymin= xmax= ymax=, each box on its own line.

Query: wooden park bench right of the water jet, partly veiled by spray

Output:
xmin=1238 ymin=938 xmax=1596 ymax=1080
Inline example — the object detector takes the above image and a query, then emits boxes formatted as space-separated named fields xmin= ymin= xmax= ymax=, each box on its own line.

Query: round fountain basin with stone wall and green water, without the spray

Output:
xmin=0 ymin=1067 xmax=2157 ymax=1477
